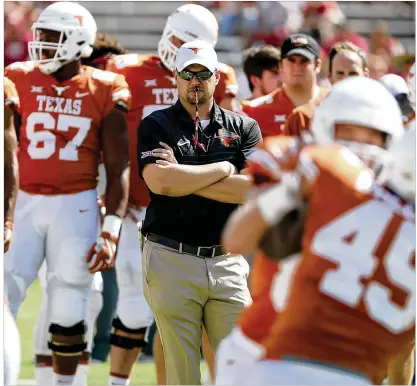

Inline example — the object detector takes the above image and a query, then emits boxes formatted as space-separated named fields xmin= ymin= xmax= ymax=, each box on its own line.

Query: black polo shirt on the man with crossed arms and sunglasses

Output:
xmin=137 ymin=101 xmax=262 ymax=246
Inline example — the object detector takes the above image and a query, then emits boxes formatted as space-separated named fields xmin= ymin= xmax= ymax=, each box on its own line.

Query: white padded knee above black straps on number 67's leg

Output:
xmin=48 ymin=278 xmax=90 ymax=327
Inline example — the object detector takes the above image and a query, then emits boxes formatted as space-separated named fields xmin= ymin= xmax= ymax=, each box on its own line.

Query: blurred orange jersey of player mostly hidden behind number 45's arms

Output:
xmin=239 ymin=136 xmax=301 ymax=344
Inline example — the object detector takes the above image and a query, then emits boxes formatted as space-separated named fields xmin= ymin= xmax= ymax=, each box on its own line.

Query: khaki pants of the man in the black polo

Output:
xmin=142 ymin=240 xmax=251 ymax=385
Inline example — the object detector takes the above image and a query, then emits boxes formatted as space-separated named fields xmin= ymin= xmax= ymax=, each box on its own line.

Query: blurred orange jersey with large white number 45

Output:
xmin=265 ymin=145 xmax=416 ymax=382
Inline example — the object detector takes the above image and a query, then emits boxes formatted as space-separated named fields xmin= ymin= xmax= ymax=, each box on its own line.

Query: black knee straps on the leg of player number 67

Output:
xmin=48 ymin=321 xmax=87 ymax=356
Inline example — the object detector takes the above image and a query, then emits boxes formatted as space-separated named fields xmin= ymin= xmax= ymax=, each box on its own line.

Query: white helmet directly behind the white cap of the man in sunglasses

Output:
xmin=158 ymin=4 xmax=219 ymax=71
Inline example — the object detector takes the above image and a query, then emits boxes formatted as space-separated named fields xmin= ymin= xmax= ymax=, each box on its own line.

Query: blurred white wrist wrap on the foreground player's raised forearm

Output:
xmin=256 ymin=173 xmax=300 ymax=226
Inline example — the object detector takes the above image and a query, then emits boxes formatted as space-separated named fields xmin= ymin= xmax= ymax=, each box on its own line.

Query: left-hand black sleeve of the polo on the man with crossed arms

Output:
xmin=137 ymin=116 xmax=172 ymax=179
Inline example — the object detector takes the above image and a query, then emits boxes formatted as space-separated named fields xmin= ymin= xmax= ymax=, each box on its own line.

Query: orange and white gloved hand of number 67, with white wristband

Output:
xmin=86 ymin=216 xmax=122 ymax=274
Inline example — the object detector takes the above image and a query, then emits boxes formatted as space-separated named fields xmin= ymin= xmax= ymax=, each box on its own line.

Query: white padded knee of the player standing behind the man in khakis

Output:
xmin=117 ymin=290 xmax=153 ymax=330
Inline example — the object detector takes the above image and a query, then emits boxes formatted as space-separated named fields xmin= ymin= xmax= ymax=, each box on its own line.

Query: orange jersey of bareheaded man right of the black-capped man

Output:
xmin=283 ymin=88 xmax=330 ymax=137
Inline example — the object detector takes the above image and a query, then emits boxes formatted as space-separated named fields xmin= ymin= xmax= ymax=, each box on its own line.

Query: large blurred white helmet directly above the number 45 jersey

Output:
xmin=310 ymin=76 xmax=404 ymax=173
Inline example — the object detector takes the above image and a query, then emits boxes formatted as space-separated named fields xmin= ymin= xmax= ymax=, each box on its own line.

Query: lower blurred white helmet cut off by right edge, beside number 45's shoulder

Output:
xmin=381 ymin=120 xmax=416 ymax=203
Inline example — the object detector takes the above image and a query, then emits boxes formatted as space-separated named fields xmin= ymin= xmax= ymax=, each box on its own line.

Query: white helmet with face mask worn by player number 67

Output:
xmin=28 ymin=1 xmax=97 ymax=74
